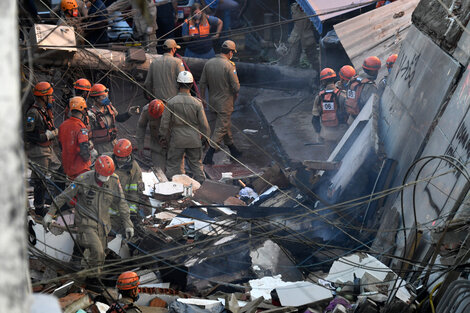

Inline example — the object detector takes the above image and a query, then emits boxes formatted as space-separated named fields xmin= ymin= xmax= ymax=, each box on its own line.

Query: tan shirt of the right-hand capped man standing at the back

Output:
xmin=200 ymin=54 xmax=240 ymax=113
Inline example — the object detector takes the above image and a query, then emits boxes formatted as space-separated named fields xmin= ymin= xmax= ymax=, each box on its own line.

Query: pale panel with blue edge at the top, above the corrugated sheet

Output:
xmin=296 ymin=0 xmax=370 ymax=34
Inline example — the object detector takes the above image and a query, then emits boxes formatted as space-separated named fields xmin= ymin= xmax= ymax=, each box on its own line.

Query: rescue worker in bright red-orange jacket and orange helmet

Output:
xmin=59 ymin=97 xmax=91 ymax=180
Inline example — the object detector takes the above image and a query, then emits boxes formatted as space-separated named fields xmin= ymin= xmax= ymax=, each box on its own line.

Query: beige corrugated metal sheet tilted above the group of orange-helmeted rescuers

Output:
xmin=334 ymin=0 xmax=419 ymax=77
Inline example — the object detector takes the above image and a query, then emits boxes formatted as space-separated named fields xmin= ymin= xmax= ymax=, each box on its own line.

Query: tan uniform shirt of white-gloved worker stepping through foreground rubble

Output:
xmin=49 ymin=170 xmax=133 ymax=233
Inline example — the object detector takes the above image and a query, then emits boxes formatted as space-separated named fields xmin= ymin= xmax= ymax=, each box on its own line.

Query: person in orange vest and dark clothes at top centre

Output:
xmin=181 ymin=3 xmax=224 ymax=59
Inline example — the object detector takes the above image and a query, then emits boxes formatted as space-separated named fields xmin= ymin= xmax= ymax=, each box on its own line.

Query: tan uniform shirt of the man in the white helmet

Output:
xmin=160 ymin=92 xmax=210 ymax=148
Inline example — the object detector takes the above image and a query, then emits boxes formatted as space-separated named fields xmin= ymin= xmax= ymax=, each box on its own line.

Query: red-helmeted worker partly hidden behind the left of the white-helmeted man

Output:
xmin=136 ymin=99 xmax=167 ymax=172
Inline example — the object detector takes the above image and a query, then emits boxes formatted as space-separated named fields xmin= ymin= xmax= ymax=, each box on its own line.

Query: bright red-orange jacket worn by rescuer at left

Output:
xmin=59 ymin=116 xmax=91 ymax=179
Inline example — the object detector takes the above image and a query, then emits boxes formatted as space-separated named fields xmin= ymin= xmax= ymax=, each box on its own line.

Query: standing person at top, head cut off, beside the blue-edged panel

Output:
xmin=280 ymin=2 xmax=320 ymax=70
